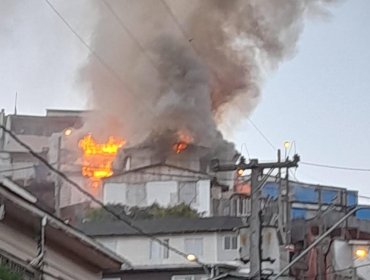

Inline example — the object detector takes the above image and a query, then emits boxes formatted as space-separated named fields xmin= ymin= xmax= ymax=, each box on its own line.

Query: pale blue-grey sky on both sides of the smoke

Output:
xmin=0 ymin=0 xmax=370 ymax=199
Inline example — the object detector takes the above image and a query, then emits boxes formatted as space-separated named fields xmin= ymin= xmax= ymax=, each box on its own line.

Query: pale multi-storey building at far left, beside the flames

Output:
xmin=0 ymin=110 xmax=82 ymax=185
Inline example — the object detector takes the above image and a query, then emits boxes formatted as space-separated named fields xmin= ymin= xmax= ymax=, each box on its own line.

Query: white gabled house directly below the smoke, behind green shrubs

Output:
xmin=103 ymin=164 xmax=212 ymax=216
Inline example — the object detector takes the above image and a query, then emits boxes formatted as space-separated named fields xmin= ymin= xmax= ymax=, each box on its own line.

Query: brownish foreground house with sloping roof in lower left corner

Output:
xmin=0 ymin=178 xmax=125 ymax=280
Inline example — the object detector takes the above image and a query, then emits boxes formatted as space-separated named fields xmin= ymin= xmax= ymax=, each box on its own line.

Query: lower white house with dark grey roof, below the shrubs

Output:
xmin=81 ymin=217 xmax=242 ymax=268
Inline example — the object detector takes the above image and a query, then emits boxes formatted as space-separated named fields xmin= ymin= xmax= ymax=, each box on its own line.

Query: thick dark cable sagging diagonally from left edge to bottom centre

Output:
xmin=0 ymin=125 xmax=207 ymax=269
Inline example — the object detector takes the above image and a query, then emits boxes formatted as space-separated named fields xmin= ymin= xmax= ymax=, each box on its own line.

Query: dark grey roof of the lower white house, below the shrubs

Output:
xmin=79 ymin=217 xmax=243 ymax=237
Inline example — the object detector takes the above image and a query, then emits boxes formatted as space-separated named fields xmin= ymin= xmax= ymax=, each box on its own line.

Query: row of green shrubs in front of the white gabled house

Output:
xmin=86 ymin=203 xmax=201 ymax=220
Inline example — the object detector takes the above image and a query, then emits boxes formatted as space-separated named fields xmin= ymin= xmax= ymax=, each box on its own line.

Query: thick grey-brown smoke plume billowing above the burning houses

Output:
xmin=82 ymin=0 xmax=334 ymax=153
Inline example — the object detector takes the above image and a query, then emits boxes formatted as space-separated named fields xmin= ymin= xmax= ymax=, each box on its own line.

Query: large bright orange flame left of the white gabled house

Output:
xmin=78 ymin=134 xmax=125 ymax=179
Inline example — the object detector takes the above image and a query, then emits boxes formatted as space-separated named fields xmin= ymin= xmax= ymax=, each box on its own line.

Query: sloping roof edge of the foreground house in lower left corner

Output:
xmin=0 ymin=179 xmax=131 ymax=269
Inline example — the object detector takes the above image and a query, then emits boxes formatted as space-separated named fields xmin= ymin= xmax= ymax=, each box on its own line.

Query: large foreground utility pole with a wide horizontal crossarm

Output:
xmin=213 ymin=155 xmax=299 ymax=280
